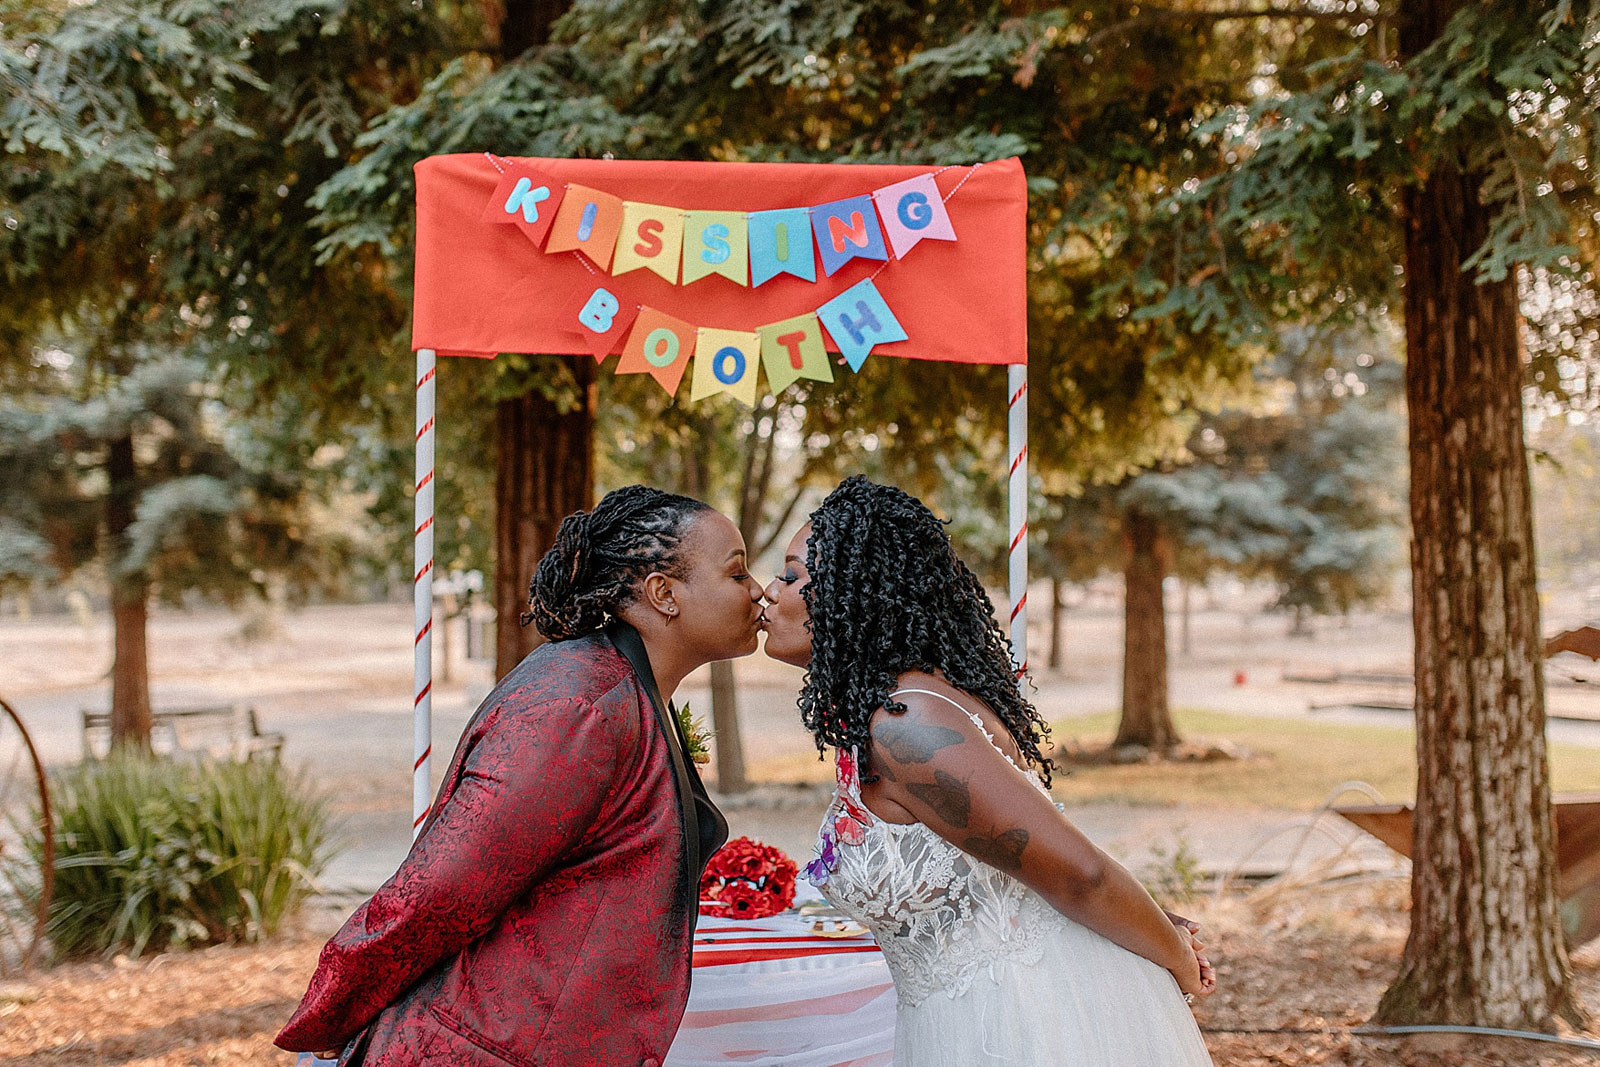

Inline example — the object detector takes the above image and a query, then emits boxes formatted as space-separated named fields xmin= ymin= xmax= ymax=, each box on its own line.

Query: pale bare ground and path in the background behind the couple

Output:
xmin=0 ymin=605 xmax=1600 ymax=894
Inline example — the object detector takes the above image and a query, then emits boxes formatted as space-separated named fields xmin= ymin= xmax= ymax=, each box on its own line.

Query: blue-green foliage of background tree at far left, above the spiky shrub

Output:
xmin=0 ymin=346 xmax=352 ymax=605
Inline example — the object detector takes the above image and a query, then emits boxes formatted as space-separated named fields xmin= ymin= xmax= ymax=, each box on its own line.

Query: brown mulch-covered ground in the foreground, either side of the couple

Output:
xmin=0 ymin=878 xmax=1600 ymax=1067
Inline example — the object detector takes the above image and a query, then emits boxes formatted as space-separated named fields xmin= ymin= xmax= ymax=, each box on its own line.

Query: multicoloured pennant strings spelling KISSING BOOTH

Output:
xmin=483 ymin=155 xmax=976 ymax=406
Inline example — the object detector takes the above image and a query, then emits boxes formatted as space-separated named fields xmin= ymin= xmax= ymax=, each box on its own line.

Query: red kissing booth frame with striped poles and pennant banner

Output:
xmin=411 ymin=152 xmax=1027 ymax=829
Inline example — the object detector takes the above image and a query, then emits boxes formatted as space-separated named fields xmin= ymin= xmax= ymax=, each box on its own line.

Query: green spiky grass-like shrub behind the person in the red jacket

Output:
xmin=34 ymin=753 xmax=331 ymax=955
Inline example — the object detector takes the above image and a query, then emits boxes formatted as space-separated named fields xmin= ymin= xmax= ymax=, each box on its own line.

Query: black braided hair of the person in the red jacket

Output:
xmin=522 ymin=485 xmax=710 ymax=641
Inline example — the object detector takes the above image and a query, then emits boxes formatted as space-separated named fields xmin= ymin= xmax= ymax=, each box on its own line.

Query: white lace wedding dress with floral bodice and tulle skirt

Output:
xmin=806 ymin=689 xmax=1211 ymax=1067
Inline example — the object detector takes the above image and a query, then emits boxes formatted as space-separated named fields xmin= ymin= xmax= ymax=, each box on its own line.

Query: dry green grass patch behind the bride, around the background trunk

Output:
xmin=1051 ymin=709 xmax=1600 ymax=811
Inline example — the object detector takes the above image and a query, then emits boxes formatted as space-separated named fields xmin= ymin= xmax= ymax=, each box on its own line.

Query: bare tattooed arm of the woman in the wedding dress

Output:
xmin=872 ymin=694 xmax=1210 ymax=993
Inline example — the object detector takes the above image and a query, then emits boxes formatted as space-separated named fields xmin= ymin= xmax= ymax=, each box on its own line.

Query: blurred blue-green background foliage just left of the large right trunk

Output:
xmin=1152 ymin=328 xmax=1406 ymax=622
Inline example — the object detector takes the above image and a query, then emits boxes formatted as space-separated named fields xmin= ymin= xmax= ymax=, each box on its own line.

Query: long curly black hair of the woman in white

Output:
xmin=800 ymin=475 xmax=1054 ymax=785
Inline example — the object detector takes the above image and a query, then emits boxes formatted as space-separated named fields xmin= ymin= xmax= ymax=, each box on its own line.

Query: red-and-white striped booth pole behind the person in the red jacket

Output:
xmin=411 ymin=349 xmax=437 ymax=838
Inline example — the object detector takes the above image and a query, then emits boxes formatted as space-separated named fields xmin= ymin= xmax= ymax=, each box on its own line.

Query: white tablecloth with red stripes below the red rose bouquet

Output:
xmin=666 ymin=915 xmax=894 ymax=1067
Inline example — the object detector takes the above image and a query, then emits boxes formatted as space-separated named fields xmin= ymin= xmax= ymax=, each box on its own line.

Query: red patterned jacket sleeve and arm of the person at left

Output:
xmin=277 ymin=701 xmax=624 ymax=1051
